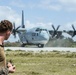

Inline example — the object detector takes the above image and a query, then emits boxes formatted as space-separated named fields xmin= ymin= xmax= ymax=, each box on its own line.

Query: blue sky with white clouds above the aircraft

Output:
xmin=0 ymin=0 xmax=76 ymax=41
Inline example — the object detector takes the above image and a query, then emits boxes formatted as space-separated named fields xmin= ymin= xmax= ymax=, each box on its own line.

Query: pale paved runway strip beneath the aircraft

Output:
xmin=5 ymin=47 xmax=76 ymax=52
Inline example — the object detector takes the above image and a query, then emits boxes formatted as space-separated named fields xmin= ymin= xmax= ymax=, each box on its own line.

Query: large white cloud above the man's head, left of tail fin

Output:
xmin=0 ymin=6 xmax=21 ymax=26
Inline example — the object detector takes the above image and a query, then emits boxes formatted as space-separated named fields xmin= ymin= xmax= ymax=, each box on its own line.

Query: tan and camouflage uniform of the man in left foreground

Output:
xmin=0 ymin=45 xmax=8 ymax=75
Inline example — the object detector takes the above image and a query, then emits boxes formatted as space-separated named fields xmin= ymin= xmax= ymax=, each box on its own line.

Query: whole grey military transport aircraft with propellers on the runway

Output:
xmin=12 ymin=10 xmax=76 ymax=47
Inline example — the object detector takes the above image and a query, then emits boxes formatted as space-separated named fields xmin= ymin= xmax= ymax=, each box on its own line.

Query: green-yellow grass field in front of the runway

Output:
xmin=5 ymin=50 xmax=76 ymax=75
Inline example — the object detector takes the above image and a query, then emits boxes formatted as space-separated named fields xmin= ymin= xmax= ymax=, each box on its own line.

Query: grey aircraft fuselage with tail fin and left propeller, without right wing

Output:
xmin=12 ymin=11 xmax=49 ymax=47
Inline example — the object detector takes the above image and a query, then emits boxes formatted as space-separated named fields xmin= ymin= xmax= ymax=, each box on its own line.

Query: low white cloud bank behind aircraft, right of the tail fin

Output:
xmin=25 ymin=20 xmax=76 ymax=31
